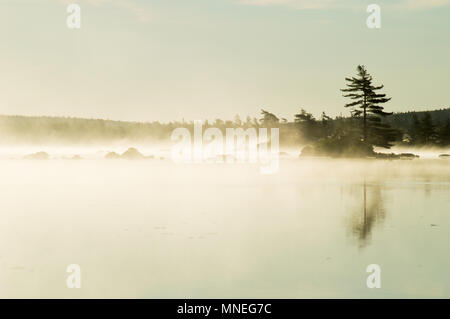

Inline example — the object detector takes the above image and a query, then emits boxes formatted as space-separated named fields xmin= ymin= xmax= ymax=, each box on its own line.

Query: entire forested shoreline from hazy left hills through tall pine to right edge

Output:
xmin=0 ymin=65 xmax=450 ymax=157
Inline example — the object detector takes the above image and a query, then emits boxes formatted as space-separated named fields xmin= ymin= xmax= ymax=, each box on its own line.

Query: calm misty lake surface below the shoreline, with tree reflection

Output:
xmin=0 ymin=158 xmax=450 ymax=298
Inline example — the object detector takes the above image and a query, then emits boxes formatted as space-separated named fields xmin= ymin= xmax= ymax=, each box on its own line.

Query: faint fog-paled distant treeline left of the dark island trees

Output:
xmin=0 ymin=112 xmax=301 ymax=145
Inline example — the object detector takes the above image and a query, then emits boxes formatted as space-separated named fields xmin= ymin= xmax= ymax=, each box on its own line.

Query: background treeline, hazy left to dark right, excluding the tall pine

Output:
xmin=0 ymin=108 xmax=450 ymax=147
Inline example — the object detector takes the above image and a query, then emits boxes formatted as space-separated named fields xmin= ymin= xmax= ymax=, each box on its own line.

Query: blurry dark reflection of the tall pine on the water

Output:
xmin=349 ymin=180 xmax=386 ymax=248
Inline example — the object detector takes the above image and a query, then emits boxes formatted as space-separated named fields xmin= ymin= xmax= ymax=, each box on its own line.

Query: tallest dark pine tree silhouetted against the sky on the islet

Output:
xmin=341 ymin=65 xmax=398 ymax=148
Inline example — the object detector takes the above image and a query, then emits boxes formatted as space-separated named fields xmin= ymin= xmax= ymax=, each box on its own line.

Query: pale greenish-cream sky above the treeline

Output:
xmin=0 ymin=0 xmax=450 ymax=122
